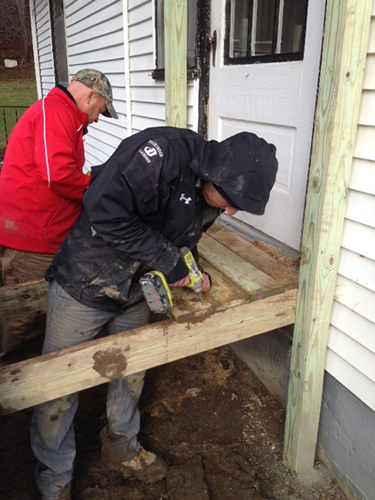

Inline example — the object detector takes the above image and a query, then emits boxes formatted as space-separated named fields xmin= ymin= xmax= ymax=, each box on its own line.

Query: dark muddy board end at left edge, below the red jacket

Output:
xmin=0 ymin=280 xmax=48 ymax=325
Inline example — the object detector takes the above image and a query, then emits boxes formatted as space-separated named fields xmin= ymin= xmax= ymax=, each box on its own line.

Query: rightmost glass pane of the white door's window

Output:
xmin=281 ymin=0 xmax=307 ymax=53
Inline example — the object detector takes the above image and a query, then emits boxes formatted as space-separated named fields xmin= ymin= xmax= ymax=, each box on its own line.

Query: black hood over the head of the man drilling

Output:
xmin=190 ymin=132 xmax=278 ymax=215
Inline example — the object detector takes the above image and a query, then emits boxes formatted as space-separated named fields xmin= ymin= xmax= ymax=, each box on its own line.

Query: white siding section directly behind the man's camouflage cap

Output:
xmin=65 ymin=0 xmax=127 ymax=166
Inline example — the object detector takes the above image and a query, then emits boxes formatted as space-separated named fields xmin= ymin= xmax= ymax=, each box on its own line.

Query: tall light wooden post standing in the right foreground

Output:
xmin=284 ymin=0 xmax=373 ymax=472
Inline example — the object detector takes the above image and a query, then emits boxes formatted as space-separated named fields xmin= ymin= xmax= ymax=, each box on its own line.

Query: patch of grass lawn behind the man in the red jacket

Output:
xmin=0 ymin=67 xmax=38 ymax=156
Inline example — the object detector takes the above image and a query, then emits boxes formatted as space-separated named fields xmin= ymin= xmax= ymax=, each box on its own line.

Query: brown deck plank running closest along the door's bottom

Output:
xmin=207 ymin=224 xmax=298 ymax=288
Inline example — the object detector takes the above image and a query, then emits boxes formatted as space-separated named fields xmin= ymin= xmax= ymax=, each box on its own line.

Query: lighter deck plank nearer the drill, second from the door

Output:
xmin=198 ymin=234 xmax=285 ymax=299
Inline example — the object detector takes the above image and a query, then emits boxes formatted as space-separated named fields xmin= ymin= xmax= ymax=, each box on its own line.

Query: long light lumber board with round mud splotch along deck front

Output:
xmin=0 ymin=290 xmax=297 ymax=414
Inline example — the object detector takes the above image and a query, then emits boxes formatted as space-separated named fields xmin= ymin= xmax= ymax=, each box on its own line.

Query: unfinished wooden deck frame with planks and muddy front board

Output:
xmin=0 ymin=225 xmax=298 ymax=414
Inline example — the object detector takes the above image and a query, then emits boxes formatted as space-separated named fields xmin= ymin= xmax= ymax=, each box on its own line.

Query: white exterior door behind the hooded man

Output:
xmin=208 ymin=0 xmax=325 ymax=249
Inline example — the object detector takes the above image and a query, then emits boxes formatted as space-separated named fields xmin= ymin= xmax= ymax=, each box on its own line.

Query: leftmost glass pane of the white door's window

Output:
xmin=229 ymin=0 xmax=250 ymax=58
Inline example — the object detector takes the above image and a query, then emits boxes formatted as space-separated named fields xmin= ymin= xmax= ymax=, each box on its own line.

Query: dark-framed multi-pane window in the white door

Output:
xmin=224 ymin=0 xmax=308 ymax=64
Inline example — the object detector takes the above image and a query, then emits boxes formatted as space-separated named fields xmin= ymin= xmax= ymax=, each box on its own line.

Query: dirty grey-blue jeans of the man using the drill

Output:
xmin=31 ymin=281 xmax=150 ymax=500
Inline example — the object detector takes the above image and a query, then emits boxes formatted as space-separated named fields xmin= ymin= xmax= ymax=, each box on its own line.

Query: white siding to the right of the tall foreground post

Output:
xmin=326 ymin=7 xmax=375 ymax=410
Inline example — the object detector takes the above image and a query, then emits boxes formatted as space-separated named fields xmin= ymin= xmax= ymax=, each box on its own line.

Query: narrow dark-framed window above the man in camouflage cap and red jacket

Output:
xmin=50 ymin=0 xmax=69 ymax=87
